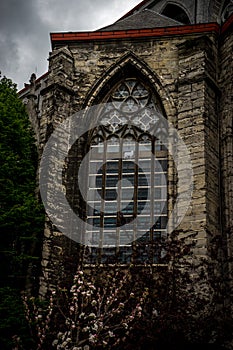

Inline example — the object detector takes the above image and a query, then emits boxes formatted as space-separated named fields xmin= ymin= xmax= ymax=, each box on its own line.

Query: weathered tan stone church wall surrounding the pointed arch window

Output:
xmin=33 ymin=28 xmax=225 ymax=295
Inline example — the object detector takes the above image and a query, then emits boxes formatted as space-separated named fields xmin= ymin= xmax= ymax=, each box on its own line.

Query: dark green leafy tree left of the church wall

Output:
xmin=0 ymin=76 xmax=44 ymax=349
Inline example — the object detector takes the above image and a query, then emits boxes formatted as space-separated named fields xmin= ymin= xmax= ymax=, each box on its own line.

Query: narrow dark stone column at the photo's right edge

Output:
xmin=219 ymin=27 xmax=233 ymax=279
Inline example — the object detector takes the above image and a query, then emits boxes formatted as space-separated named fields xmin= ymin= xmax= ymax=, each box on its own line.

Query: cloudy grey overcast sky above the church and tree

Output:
xmin=0 ymin=0 xmax=141 ymax=89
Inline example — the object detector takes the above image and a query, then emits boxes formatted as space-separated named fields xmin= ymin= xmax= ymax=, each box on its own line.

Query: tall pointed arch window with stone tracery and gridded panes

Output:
xmin=86 ymin=78 xmax=168 ymax=263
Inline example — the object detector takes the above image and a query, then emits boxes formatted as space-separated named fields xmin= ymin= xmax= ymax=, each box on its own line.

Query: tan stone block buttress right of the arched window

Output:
xmin=178 ymin=37 xmax=220 ymax=257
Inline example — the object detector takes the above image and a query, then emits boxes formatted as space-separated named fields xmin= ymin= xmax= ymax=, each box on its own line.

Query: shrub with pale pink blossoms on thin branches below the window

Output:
xmin=21 ymin=268 xmax=149 ymax=350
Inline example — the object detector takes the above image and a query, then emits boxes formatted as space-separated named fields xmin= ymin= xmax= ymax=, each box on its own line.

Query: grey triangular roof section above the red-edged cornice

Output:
xmin=98 ymin=8 xmax=182 ymax=31
